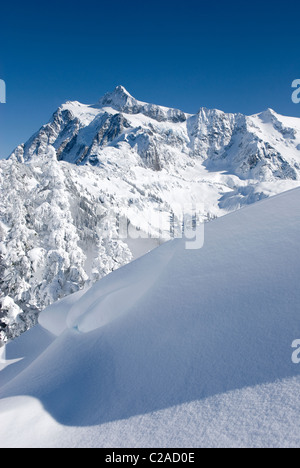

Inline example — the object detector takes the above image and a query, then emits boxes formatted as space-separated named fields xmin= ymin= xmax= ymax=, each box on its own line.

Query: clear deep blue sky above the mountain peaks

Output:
xmin=0 ymin=0 xmax=300 ymax=157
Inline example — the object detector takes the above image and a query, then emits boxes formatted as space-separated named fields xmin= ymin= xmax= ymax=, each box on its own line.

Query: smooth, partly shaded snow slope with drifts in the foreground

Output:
xmin=0 ymin=189 xmax=300 ymax=447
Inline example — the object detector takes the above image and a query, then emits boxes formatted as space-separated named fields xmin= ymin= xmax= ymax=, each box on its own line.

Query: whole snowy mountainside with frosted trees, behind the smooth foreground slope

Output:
xmin=0 ymin=86 xmax=300 ymax=341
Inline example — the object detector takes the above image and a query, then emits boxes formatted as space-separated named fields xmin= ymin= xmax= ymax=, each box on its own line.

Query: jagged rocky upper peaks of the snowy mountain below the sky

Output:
xmin=11 ymin=86 xmax=300 ymax=180
